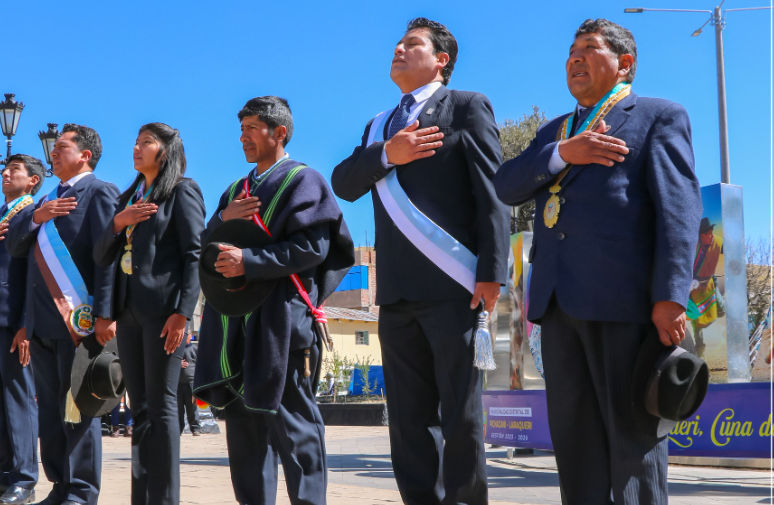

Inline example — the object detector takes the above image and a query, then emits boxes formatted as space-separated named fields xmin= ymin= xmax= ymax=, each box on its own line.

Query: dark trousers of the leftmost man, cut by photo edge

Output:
xmin=0 ymin=328 xmax=38 ymax=489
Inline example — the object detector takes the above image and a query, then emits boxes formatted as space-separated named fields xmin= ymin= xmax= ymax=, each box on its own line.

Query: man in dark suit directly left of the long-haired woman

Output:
xmin=6 ymin=124 xmax=119 ymax=505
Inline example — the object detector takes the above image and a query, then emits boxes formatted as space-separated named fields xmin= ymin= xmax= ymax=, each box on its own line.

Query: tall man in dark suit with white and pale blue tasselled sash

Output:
xmin=331 ymin=18 xmax=509 ymax=505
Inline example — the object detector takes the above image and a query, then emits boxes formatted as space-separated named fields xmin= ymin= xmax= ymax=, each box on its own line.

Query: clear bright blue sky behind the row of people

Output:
xmin=0 ymin=0 xmax=772 ymax=245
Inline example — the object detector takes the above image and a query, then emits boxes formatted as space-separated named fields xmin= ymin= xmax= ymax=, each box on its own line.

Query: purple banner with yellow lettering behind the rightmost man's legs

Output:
xmin=483 ymin=382 xmax=772 ymax=458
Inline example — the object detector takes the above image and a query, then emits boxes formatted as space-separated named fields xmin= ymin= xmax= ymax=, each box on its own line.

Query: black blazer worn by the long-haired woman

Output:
xmin=94 ymin=179 xmax=205 ymax=322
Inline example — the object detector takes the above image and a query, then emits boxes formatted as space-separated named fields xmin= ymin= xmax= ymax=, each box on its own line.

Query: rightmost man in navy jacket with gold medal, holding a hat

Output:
xmin=495 ymin=19 xmax=701 ymax=504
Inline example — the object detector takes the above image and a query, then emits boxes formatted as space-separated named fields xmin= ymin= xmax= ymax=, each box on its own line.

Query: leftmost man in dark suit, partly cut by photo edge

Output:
xmin=0 ymin=154 xmax=46 ymax=503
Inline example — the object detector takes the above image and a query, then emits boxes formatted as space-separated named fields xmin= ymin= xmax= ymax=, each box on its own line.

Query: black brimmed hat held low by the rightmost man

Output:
xmin=632 ymin=326 xmax=709 ymax=438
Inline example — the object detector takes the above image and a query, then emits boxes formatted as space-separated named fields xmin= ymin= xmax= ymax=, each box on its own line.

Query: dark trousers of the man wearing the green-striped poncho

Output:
xmin=224 ymin=347 xmax=328 ymax=505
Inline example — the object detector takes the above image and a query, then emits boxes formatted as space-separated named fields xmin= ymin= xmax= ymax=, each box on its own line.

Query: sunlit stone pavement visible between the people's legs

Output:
xmin=30 ymin=421 xmax=772 ymax=505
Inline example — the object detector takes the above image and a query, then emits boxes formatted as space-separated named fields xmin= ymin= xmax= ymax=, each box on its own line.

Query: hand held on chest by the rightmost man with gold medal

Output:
xmin=559 ymin=120 xmax=629 ymax=167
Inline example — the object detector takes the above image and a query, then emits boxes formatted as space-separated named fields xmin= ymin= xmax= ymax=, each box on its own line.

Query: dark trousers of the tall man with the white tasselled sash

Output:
xmin=379 ymin=300 xmax=487 ymax=505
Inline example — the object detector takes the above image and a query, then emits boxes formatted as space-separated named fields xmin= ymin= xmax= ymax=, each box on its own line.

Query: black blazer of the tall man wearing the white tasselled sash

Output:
xmin=331 ymin=86 xmax=510 ymax=305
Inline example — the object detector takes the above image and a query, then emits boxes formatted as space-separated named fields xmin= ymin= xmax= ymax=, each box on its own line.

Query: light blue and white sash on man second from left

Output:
xmin=38 ymin=189 xmax=93 ymax=316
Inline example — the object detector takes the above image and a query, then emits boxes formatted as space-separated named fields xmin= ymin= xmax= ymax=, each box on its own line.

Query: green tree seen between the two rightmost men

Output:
xmin=497 ymin=105 xmax=548 ymax=233
